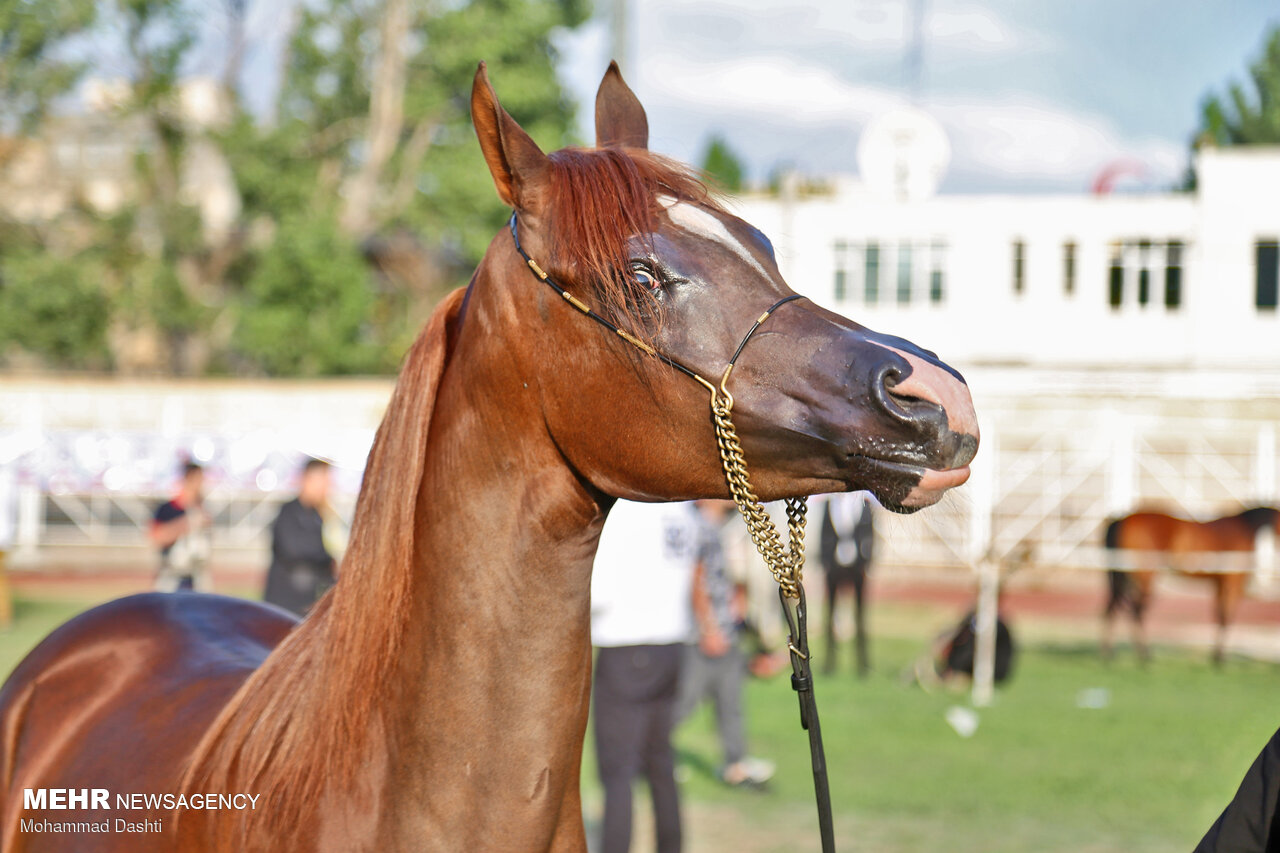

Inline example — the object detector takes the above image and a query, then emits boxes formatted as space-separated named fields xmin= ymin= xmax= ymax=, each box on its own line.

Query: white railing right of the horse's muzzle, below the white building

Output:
xmin=878 ymin=406 xmax=1277 ymax=569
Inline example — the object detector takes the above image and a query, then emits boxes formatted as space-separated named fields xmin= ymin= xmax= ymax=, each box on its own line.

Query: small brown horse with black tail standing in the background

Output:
xmin=1102 ymin=507 xmax=1280 ymax=663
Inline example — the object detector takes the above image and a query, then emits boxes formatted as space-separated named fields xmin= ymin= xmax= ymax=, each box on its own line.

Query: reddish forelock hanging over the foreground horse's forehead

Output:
xmin=547 ymin=147 xmax=723 ymax=332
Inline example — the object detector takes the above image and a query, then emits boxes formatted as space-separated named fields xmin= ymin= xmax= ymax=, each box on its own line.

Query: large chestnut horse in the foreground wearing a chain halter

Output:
xmin=0 ymin=64 xmax=978 ymax=853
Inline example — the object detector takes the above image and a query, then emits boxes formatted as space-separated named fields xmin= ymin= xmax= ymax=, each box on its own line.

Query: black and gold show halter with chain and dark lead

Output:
xmin=507 ymin=211 xmax=836 ymax=853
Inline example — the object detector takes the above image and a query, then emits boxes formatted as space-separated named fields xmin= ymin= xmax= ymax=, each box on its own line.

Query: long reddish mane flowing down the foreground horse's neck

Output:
xmin=182 ymin=288 xmax=465 ymax=835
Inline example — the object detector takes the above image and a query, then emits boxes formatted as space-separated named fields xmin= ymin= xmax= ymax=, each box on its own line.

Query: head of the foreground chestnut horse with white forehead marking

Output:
xmin=471 ymin=64 xmax=978 ymax=511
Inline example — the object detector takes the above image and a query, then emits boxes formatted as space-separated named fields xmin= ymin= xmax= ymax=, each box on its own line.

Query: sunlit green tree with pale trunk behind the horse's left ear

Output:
xmin=280 ymin=0 xmax=586 ymax=272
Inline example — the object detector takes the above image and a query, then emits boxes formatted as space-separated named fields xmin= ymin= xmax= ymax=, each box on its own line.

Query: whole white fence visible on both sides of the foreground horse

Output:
xmin=0 ymin=368 xmax=1280 ymax=567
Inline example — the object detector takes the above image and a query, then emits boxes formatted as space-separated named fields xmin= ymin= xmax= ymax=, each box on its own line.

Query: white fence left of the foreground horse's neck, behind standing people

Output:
xmin=0 ymin=379 xmax=392 ymax=565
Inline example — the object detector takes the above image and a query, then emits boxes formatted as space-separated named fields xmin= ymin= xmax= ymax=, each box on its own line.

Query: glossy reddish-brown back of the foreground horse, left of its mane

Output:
xmin=0 ymin=593 xmax=296 ymax=853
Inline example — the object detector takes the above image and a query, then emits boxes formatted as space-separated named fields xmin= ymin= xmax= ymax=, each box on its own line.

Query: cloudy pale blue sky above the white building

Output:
xmin=558 ymin=0 xmax=1280 ymax=192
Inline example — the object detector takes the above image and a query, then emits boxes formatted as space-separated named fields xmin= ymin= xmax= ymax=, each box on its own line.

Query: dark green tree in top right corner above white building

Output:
xmin=1194 ymin=27 xmax=1280 ymax=147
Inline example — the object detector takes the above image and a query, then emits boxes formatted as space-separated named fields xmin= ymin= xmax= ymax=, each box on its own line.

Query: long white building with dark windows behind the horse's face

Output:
xmin=739 ymin=147 xmax=1280 ymax=370
